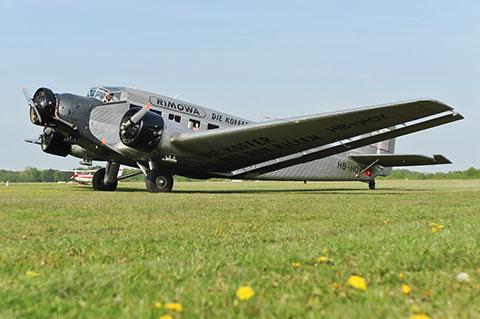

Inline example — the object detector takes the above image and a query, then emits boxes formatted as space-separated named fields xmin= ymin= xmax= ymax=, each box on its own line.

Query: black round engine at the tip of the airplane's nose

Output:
xmin=30 ymin=88 xmax=57 ymax=126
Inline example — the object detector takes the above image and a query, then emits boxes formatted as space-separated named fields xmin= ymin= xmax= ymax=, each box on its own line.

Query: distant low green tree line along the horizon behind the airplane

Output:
xmin=0 ymin=167 xmax=480 ymax=183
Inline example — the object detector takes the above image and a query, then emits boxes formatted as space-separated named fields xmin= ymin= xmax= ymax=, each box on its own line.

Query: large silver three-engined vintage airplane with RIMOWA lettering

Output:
xmin=24 ymin=86 xmax=463 ymax=193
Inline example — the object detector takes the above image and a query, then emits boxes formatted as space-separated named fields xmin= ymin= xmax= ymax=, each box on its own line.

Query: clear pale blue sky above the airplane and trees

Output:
xmin=0 ymin=0 xmax=480 ymax=171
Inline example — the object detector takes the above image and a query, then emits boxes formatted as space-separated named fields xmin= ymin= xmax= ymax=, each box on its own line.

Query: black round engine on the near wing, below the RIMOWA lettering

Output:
xmin=120 ymin=108 xmax=164 ymax=152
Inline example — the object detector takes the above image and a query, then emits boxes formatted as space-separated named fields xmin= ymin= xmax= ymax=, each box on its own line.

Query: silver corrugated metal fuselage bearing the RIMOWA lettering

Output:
xmin=85 ymin=88 xmax=389 ymax=181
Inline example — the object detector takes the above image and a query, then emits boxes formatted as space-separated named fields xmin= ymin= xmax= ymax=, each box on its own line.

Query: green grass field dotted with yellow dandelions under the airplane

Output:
xmin=0 ymin=180 xmax=480 ymax=318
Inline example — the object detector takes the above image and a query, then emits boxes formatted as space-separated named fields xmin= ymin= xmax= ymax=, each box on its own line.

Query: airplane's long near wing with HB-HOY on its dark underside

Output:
xmin=171 ymin=100 xmax=458 ymax=172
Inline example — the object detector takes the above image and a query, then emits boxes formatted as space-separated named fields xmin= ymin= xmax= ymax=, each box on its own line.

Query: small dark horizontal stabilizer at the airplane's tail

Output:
xmin=350 ymin=154 xmax=452 ymax=167
